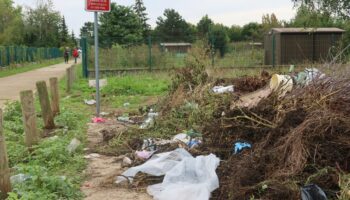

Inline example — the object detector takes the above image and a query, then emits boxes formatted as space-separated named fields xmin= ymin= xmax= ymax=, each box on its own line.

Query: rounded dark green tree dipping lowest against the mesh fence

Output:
xmin=209 ymin=24 xmax=230 ymax=57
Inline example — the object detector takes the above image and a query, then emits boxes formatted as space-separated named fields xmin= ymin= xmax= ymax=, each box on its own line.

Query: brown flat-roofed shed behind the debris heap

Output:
xmin=264 ymin=28 xmax=345 ymax=65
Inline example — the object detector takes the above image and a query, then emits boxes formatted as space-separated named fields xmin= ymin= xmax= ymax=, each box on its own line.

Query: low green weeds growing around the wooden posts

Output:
xmin=4 ymin=69 xmax=90 ymax=200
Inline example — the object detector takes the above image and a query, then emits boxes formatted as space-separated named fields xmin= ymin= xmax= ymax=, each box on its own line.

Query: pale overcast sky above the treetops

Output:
xmin=14 ymin=0 xmax=295 ymax=35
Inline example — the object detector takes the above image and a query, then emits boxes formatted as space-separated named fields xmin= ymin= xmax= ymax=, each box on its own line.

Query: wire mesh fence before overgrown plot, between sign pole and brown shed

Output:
xmin=82 ymin=37 xmax=264 ymax=73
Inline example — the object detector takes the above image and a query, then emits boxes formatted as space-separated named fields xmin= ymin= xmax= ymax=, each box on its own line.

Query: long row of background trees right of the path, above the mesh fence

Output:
xmin=80 ymin=0 xmax=350 ymax=55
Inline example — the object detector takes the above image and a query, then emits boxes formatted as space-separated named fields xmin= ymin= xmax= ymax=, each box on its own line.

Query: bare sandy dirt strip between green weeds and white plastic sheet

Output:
xmin=81 ymin=120 xmax=152 ymax=200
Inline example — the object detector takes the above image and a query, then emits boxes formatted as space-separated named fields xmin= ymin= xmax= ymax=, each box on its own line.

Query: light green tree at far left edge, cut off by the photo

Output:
xmin=0 ymin=0 xmax=23 ymax=45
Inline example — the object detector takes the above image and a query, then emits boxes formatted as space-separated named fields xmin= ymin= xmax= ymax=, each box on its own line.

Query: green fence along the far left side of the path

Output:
xmin=0 ymin=46 xmax=62 ymax=67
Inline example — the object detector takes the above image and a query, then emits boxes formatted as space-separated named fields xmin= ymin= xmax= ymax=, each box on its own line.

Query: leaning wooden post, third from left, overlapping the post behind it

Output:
xmin=36 ymin=81 xmax=55 ymax=129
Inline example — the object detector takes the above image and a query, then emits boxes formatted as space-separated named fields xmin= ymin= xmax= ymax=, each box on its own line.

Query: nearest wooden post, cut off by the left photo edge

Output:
xmin=0 ymin=109 xmax=11 ymax=199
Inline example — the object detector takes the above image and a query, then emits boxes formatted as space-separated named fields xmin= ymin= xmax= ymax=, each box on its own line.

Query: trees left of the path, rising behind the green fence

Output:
xmin=0 ymin=0 xmax=77 ymax=47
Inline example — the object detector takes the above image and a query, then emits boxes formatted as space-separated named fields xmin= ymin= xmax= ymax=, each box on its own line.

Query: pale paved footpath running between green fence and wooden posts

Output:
xmin=0 ymin=61 xmax=77 ymax=108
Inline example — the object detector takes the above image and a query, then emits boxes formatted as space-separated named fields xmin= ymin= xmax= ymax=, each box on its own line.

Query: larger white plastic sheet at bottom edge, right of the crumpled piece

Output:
xmin=147 ymin=154 xmax=220 ymax=200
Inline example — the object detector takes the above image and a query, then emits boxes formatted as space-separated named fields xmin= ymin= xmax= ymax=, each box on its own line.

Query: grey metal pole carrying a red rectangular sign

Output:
xmin=85 ymin=0 xmax=111 ymax=117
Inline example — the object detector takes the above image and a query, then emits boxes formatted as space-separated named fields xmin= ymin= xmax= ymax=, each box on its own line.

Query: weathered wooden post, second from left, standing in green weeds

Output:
xmin=20 ymin=90 xmax=39 ymax=148
